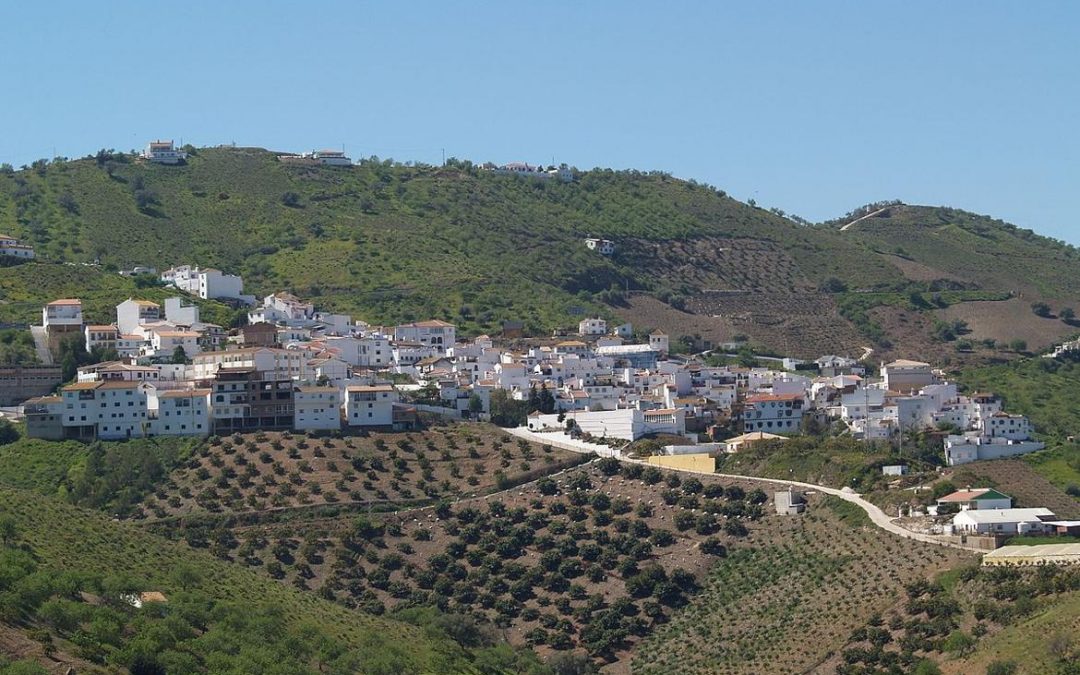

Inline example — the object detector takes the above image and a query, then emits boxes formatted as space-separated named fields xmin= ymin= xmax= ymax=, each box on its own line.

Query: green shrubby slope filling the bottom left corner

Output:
xmin=0 ymin=488 xmax=477 ymax=673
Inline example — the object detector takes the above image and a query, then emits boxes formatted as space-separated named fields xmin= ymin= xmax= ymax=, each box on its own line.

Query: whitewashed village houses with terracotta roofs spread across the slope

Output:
xmin=6 ymin=238 xmax=1080 ymax=564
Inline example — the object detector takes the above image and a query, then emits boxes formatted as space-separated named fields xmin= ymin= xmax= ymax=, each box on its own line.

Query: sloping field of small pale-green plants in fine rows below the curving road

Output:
xmin=633 ymin=498 xmax=972 ymax=674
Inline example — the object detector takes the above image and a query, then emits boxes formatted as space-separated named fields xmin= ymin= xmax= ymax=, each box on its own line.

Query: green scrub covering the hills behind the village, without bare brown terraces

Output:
xmin=6 ymin=148 xmax=1080 ymax=341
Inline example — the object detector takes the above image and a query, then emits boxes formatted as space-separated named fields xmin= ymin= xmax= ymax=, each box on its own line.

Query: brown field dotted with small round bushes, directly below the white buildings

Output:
xmin=135 ymin=424 xmax=581 ymax=519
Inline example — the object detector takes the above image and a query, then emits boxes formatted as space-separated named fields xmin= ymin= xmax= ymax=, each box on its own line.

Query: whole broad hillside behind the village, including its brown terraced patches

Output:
xmin=0 ymin=148 xmax=1080 ymax=359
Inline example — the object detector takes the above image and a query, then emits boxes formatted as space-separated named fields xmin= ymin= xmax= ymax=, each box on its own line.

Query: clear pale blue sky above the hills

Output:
xmin=0 ymin=0 xmax=1080 ymax=244
